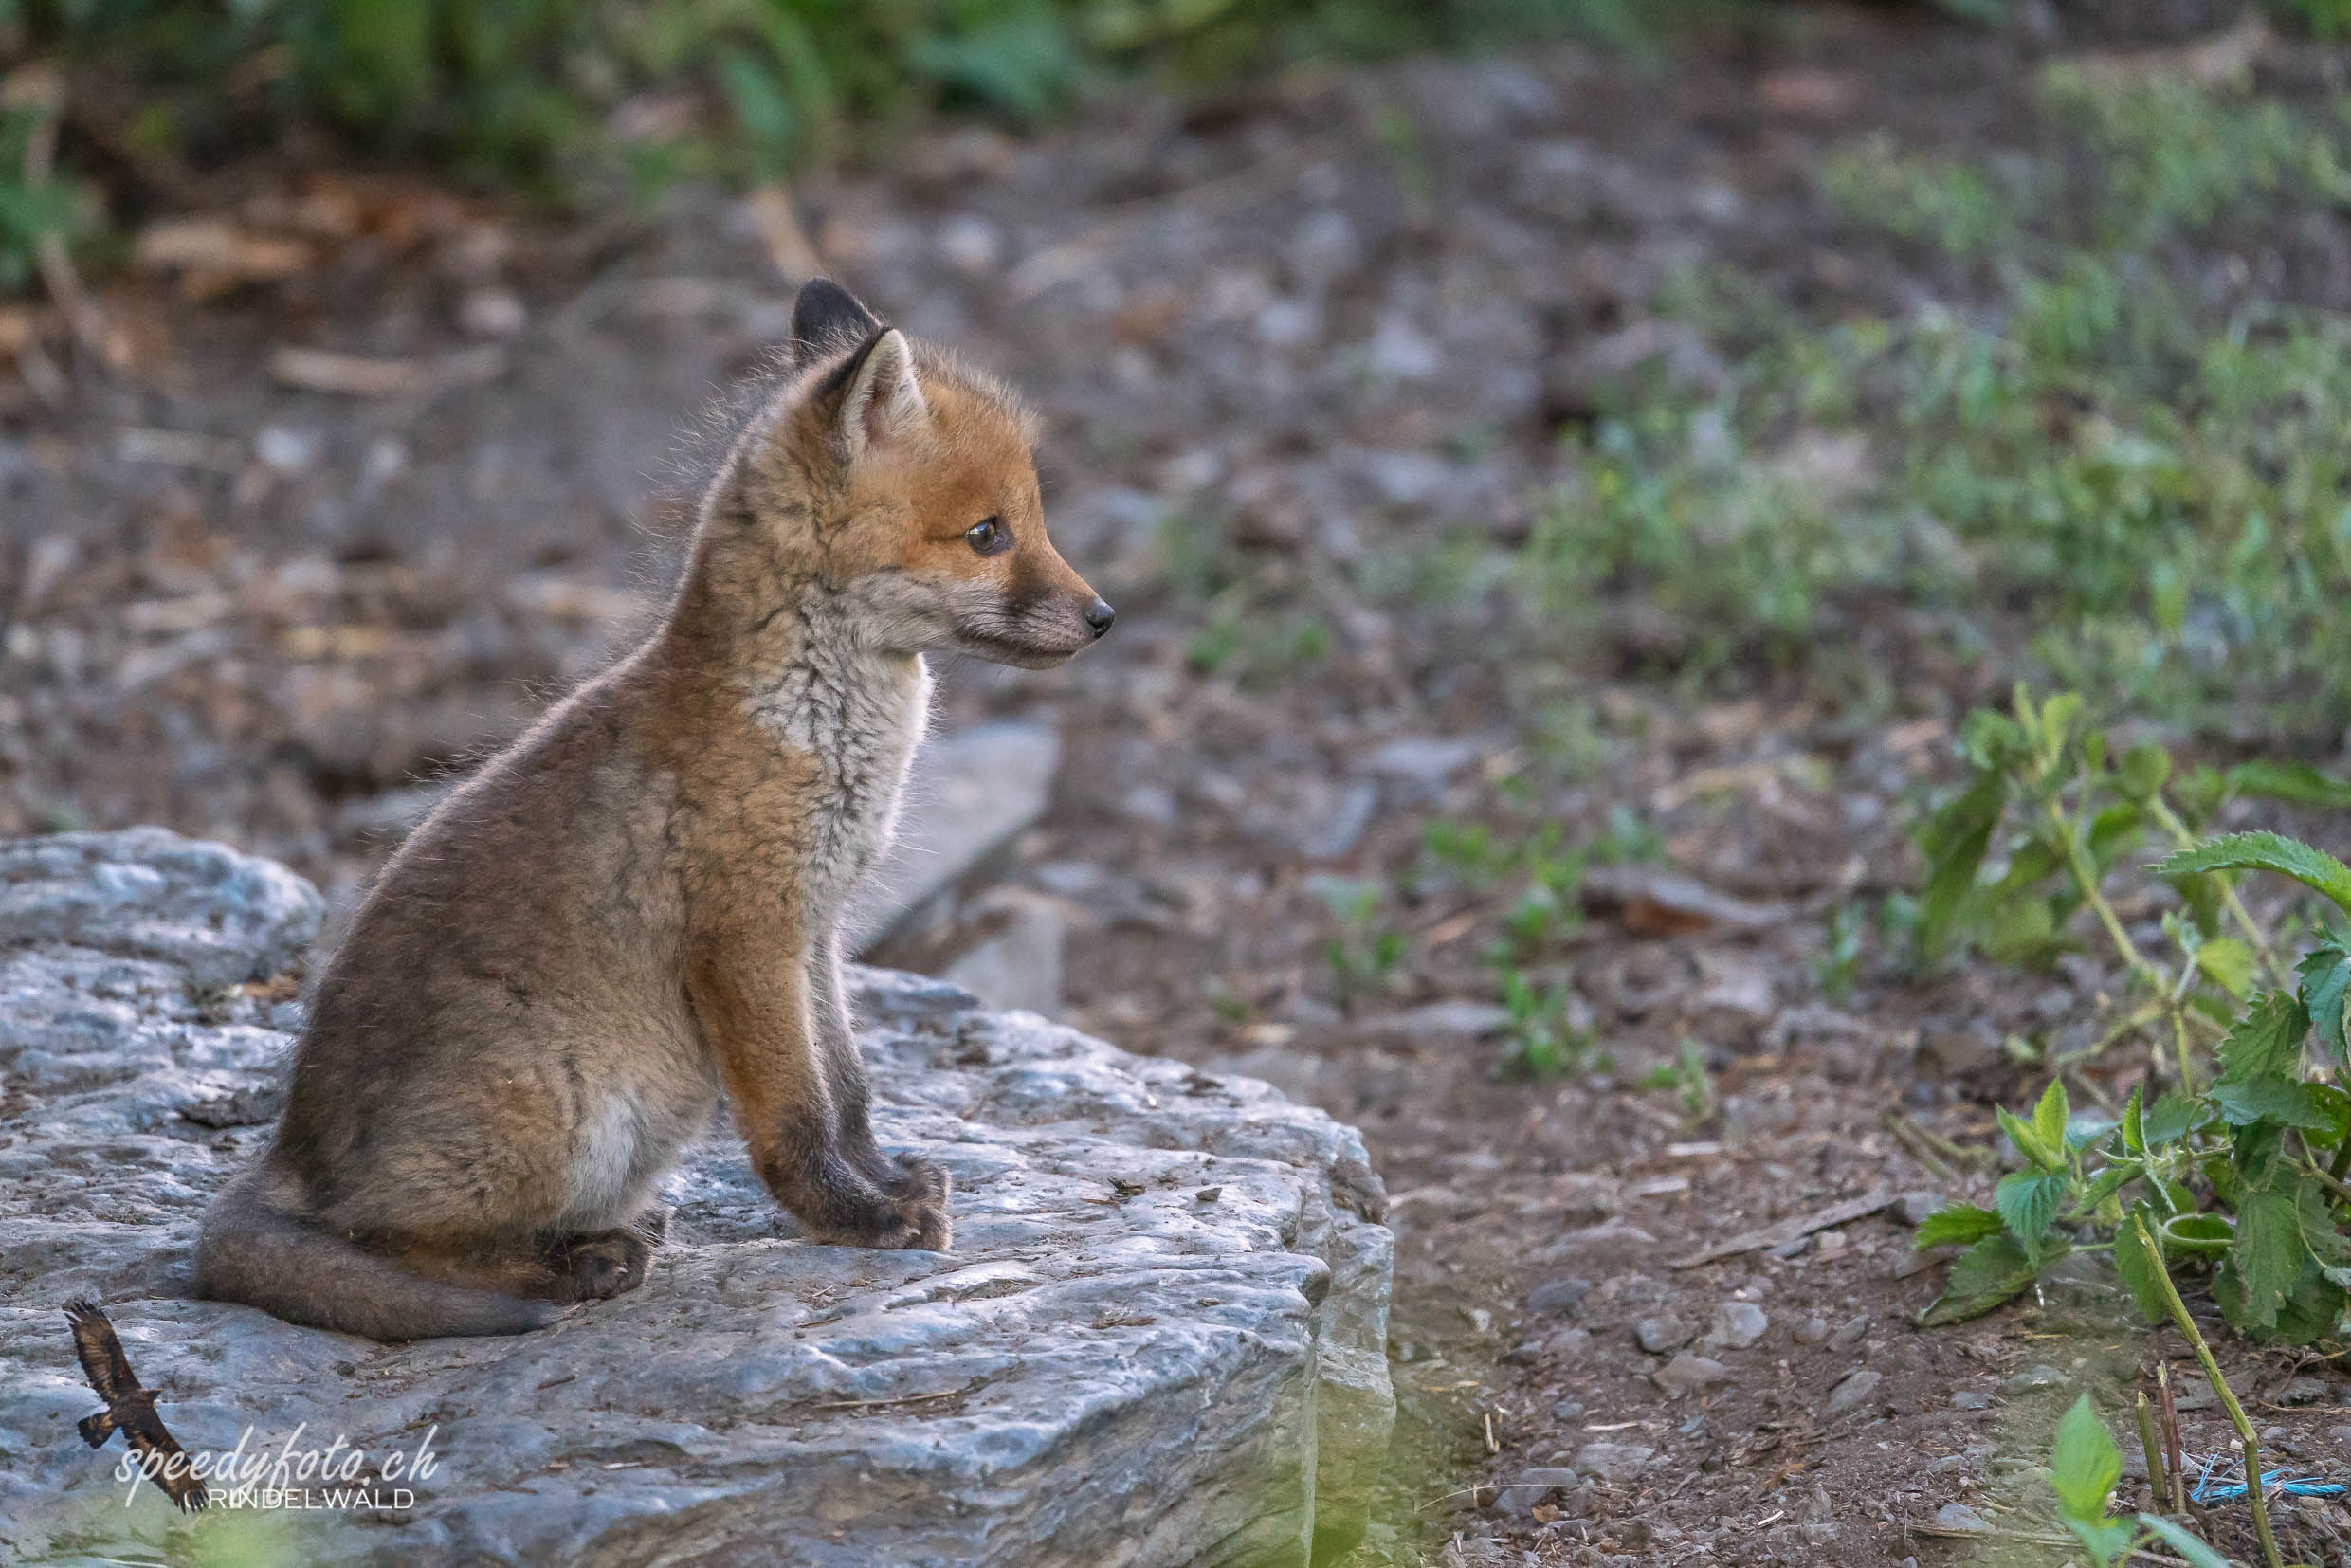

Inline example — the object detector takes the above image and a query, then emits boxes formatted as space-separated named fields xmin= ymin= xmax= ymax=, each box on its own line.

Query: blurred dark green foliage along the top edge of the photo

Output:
xmin=0 ymin=0 xmax=1703 ymax=181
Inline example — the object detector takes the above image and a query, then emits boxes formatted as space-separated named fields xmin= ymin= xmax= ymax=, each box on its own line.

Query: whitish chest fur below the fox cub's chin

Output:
xmin=753 ymin=621 xmax=931 ymax=920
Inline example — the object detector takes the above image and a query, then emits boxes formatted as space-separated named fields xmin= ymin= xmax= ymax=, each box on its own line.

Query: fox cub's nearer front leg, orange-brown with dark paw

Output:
xmin=686 ymin=938 xmax=947 ymax=1250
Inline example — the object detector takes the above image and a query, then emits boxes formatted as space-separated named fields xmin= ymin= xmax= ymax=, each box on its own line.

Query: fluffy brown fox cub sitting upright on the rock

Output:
xmin=195 ymin=280 xmax=1112 ymax=1340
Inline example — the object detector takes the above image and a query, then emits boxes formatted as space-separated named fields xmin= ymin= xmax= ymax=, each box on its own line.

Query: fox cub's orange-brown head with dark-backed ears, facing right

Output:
xmin=740 ymin=278 xmax=1112 ymax=670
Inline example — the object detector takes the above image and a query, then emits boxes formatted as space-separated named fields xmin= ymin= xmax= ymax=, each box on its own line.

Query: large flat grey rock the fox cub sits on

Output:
xmin=0 ymin=830 xmax=1394 ymax=1568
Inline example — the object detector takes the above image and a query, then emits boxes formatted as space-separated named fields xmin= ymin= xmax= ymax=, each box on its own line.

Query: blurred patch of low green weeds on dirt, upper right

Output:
xmin=1453 ymin=65 xmax=2351 ymax=740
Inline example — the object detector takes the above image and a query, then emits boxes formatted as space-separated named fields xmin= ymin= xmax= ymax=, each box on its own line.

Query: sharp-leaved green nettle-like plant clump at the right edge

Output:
xmin=1919 ymin=689 xmax=2351 ymax=1344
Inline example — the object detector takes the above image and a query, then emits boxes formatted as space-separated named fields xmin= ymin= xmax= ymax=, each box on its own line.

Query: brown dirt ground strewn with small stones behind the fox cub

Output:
xmin=0 ymin=7 xmax=2351 ymax=1566
